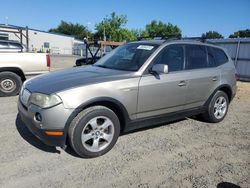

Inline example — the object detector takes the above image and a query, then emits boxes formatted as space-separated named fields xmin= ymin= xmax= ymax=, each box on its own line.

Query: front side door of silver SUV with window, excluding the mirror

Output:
xmin=137 ymin=44 xmax=189 ymax=118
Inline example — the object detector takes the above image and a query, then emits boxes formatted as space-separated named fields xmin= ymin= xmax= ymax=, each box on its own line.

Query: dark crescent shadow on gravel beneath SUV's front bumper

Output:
xmin=16 ymin=114 xmax=60 ymax=154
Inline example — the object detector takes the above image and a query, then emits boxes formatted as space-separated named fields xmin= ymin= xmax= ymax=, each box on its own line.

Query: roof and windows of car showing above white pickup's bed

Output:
xmin=0 ymin=40 xmax=27 ymax=53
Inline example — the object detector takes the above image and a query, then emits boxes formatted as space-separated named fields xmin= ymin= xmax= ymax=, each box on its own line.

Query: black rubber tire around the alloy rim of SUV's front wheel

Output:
xmin=68 ymin=106 xmax=120 ymax=158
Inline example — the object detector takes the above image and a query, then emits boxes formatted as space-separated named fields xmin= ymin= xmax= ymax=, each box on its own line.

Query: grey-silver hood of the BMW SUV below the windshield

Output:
xmin=25 ymin=65 xmax=134 ymax=94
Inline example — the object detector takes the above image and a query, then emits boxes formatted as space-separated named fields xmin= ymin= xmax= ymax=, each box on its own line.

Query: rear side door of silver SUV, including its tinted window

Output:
xmin=185 ymin=45 xmax=220 ymax=109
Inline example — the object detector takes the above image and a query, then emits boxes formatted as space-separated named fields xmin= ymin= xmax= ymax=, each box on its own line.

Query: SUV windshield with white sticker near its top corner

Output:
xmin=94 ymin=43 xmax=158 ymax=71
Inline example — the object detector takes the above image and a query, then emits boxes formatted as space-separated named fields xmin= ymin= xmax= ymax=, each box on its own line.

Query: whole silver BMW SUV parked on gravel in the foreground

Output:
xmin=18 ymin=40 xmax=236 ymax=157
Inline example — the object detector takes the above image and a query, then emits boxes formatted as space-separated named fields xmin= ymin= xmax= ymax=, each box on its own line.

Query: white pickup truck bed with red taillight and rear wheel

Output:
xmin=0 ymin=53 xmax=50 ymax=96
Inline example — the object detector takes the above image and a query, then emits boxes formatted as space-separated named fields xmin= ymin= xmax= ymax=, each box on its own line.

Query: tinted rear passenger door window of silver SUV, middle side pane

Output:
xmin=186 ymin=45 xmax=207 ymax=69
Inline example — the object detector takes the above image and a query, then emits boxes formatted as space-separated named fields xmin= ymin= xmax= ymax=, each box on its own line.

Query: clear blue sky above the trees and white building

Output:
xmin=0 ymin=0 xmax=250 ymax=37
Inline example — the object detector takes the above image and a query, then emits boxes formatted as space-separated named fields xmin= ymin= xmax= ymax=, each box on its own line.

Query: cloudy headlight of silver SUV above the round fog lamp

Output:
xmin=30 ymin=93 xmax=62 ymax=108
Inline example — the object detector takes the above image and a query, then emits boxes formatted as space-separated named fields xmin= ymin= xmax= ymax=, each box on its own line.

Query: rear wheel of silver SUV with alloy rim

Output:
xmin=202 ymin=91 xmax=229 ymax=123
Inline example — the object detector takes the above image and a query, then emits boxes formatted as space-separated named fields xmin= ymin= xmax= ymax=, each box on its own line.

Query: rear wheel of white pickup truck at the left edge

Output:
xmin=0 ymin=71 xmax=22 ymax=97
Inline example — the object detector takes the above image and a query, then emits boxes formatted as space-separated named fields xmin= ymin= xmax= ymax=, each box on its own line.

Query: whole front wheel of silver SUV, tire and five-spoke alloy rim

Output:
xmin=69 ymin=106 xmax=120 ymax=158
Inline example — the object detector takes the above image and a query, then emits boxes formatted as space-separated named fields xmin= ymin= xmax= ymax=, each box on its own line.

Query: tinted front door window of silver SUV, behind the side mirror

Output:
xmin=154 ymin=45 xmax=184 ymax=72
